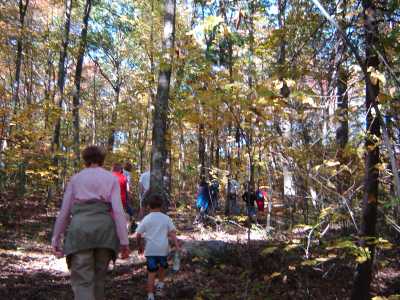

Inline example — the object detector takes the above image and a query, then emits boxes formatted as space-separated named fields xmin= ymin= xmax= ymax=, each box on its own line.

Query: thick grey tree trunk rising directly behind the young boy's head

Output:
xmin=150 ymin=0 xmax=176 ymax=204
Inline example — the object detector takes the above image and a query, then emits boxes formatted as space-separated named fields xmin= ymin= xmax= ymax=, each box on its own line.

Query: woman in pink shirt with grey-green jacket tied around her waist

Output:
xmin=51 ymin=146 xmax=129 ymax=300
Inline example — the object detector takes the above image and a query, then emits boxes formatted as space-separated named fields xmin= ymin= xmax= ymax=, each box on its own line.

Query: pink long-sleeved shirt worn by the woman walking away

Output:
xmin=51 ymin=167 xmax=128 ymax=248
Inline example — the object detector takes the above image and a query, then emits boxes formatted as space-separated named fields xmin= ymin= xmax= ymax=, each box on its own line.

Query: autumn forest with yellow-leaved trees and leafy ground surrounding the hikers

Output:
xmin=0 ymin=0 xmax=400 ymax=300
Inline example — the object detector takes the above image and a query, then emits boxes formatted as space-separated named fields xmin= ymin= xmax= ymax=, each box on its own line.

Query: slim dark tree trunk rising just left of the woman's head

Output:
xmin=72 ymin=0 xmax=92 ymax=169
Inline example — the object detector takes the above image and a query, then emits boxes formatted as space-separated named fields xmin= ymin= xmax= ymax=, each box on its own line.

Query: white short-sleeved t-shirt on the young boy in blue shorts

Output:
xmin=136 ymin=212 xmax=175 ymax=256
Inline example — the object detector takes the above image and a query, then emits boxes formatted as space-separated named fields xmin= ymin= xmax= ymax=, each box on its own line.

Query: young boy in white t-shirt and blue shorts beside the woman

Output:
xmin=136 ymin=194 xmax=180 ymax=300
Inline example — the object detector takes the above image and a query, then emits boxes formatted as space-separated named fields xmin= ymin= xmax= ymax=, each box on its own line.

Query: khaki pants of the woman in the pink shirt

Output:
xmin=71 ymin=248 xmax=112 ymax=300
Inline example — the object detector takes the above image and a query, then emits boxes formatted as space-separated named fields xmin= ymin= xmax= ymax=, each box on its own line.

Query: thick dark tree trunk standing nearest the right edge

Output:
xmin=351 ymin=0 xmax=381 ymax=300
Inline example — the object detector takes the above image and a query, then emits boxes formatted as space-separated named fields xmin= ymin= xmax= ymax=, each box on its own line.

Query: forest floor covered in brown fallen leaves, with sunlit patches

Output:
xmin=0 ymin=193 xmax=400 ymax=300
